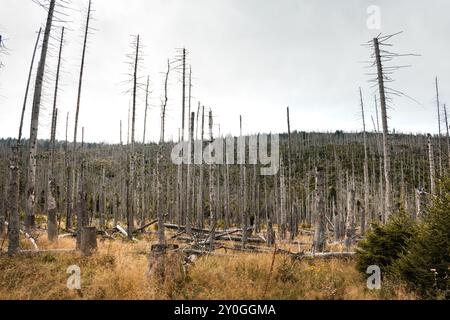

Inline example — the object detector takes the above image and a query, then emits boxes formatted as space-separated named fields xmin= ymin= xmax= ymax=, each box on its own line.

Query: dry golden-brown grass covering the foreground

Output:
xmin=0 ymin=224 xmax=416 ymax=300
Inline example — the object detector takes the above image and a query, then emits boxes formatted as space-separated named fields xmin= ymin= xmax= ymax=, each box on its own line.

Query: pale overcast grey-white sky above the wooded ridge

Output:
xmin=0 ymin=0 xmax=450 ymax=142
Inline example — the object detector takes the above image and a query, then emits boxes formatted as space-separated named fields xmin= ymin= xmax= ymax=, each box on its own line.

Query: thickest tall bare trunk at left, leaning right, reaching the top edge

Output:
xmin=25 ymin=0 xmax=55 ymax=229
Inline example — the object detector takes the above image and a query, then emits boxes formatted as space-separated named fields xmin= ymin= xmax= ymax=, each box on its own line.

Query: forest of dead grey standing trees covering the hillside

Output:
xmin=0 ymin=0 xmax=450 ymax=300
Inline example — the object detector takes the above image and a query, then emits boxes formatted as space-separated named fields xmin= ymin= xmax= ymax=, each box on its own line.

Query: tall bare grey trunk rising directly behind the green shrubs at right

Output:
xmin=373 ymin=38 xmax=392 ymax=222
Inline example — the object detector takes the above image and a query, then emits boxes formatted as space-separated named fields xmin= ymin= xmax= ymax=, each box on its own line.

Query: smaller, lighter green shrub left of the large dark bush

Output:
xmin=356 ymin=213 xmax=416 ymax=274
